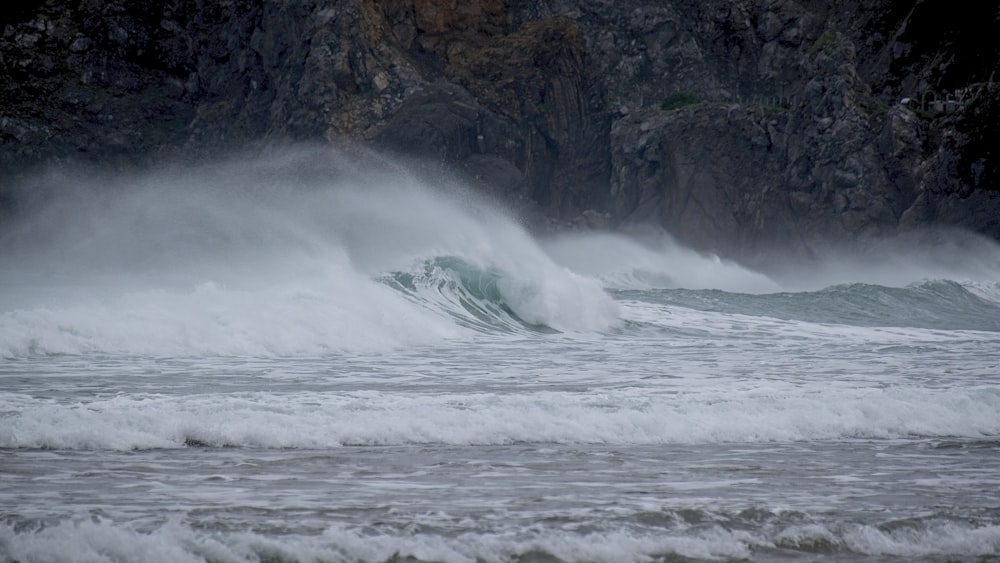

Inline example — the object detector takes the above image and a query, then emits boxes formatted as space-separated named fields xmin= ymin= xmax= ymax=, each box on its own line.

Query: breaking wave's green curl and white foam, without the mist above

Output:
xmin=0 ymin=251 xmax=619 ymax=358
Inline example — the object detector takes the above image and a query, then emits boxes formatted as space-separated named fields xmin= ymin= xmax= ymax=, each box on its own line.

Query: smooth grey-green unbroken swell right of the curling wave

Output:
xmin=617 ymin=280 xmax=1000 ymax=332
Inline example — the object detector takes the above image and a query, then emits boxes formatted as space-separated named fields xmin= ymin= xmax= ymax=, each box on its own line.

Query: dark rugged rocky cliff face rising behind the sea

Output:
xmin=0 ymin=0 xmax=1000 ymax=259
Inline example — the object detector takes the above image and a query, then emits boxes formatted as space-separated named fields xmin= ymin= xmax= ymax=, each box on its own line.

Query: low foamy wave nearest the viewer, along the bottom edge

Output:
xmin=0 ymin=509 xmax=1000 ymax=563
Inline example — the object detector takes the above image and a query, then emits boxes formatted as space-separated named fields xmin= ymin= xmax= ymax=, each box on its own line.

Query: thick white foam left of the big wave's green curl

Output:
xmin=0 ymin=274 xmax=462 ymax=357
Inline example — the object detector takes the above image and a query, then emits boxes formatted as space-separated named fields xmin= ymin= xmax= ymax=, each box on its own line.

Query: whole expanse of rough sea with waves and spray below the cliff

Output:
xmin=0 ymin=152 xmax=1000 ymax=562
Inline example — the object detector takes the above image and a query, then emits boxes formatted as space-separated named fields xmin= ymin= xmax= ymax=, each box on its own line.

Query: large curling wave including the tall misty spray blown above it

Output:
xmin=0 ymin=152 xmax=619 ymax=357
